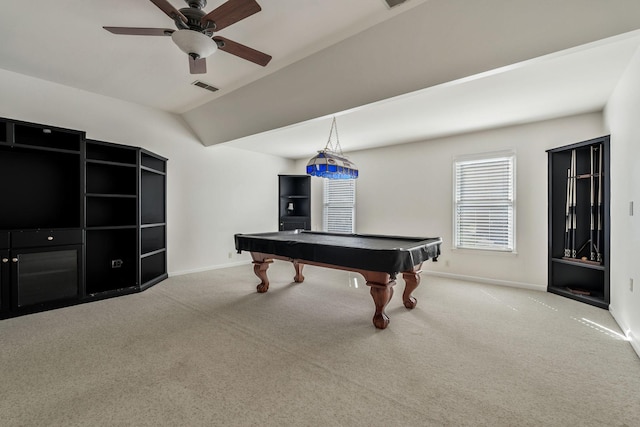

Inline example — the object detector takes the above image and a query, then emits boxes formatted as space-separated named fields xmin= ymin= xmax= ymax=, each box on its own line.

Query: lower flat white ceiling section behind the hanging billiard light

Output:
xmin=229 ymin=31 xmax=640 ymax=159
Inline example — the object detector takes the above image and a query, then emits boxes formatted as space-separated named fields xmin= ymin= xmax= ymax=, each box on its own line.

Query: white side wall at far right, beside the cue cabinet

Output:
xmin=605 ymin=46 xmax=640 ymax=355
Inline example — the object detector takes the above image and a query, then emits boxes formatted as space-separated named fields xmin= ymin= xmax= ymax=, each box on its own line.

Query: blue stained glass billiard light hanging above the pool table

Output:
xmin=307 ymin=117 xmax=358 ymax=179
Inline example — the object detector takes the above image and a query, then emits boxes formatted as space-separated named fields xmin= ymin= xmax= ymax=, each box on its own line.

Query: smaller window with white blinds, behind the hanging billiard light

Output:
xmin=322 ymin=179 xmax=356 ymax=233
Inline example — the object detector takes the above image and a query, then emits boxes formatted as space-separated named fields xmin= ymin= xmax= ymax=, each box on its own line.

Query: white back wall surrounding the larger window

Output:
xmin=297 ymin=113 xmax=608 ymax=290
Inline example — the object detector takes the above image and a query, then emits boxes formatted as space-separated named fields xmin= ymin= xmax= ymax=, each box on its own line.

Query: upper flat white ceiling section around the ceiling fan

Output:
xmin=0 ymin=0 xmax=425 ymax=113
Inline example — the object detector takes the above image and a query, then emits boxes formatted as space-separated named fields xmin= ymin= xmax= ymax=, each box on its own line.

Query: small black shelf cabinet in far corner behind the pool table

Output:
xmin=278 ymin=175 xmax=311 ymax=231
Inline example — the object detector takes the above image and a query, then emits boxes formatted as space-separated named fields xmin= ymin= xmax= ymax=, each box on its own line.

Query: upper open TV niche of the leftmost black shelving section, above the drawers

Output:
xmin=0 ymin=119 xmax=84 ymax=230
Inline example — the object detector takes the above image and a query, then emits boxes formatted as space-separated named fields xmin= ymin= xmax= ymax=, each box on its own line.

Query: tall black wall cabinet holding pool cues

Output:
xmin=547 ymin=136 xmax=610 ymax=309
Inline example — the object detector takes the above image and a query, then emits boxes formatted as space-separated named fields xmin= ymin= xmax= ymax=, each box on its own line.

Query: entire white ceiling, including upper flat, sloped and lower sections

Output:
xmin=0 ymin=0 xmax=640 ymax=158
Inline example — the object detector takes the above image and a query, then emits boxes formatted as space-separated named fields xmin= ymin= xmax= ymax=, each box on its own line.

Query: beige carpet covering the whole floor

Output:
xmin=0 ymin=262 xmax=640 ymax=426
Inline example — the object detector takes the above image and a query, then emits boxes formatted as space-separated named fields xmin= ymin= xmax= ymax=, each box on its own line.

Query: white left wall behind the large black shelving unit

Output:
xmin=0 ymin=70 xmax=293 ymax=274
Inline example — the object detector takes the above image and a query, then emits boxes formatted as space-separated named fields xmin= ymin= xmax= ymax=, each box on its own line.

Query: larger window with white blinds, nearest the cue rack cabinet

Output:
xmin=454 ymin=153 xmax=515 ymax=252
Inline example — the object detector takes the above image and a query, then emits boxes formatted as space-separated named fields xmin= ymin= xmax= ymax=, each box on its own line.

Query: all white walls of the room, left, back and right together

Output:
xmin=0 ymin=67 xmax=640 ymax=349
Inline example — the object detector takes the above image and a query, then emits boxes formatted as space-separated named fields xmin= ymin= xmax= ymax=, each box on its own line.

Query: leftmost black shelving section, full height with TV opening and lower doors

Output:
xmin=0 ymin=119 xmax=84 ymax=317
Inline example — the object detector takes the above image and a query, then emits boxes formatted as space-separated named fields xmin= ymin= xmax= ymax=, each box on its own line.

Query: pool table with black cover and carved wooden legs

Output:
xmin=235 ymin=230 xmax=442 ymax=329
